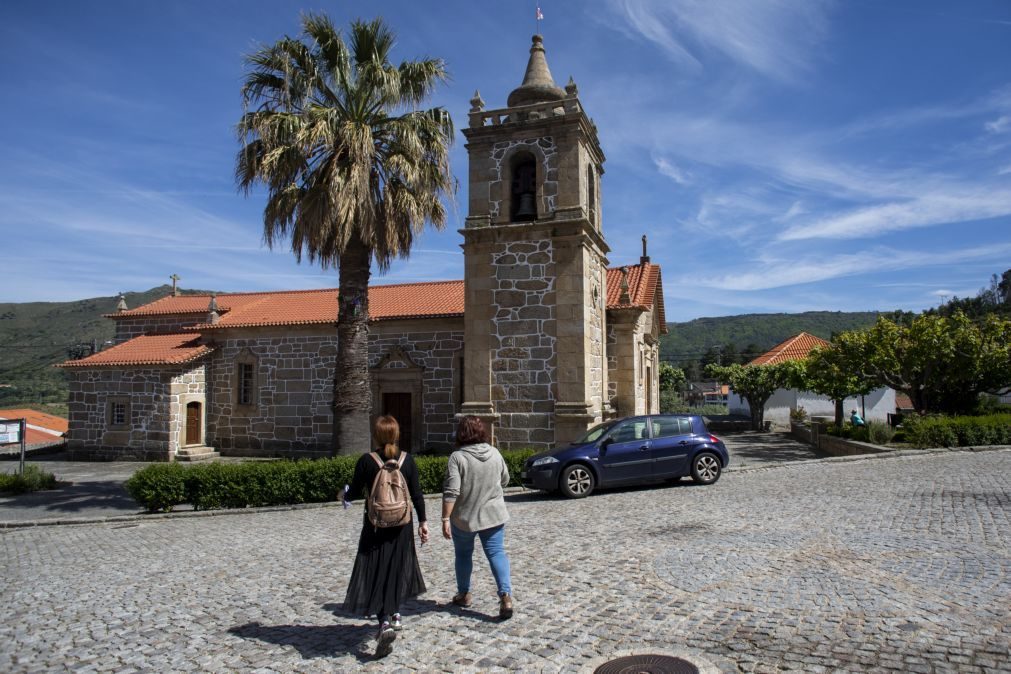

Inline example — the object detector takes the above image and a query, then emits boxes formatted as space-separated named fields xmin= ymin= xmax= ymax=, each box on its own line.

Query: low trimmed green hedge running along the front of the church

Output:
xmin=124 ymin=450 xmax=535 ymax=512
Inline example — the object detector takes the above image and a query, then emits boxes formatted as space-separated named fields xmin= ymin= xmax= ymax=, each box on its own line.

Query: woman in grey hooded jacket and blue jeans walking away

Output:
xmin=443 ymin=416 xmax=513 ymax=619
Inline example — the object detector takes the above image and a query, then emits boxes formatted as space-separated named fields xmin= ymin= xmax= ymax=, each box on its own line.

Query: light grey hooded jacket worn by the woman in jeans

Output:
xmin=443 ymin=443 xmax=509 ymax=532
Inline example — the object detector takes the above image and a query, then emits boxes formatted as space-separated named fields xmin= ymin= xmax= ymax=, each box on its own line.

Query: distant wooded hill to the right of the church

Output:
xmin=660 ymin=311 xmax=878 ymax=363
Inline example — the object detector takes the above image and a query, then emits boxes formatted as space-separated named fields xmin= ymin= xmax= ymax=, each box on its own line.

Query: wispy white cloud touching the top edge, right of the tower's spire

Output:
xmin=611 ymin=0 xmax=829 ymax=80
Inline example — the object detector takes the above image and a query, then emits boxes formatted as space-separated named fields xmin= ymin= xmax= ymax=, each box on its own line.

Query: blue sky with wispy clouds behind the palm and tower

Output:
xmin=0 ymin=0 xmax=1011 ymax=320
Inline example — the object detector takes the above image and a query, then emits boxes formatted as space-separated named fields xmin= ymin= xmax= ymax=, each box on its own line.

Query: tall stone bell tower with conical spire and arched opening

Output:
xmin=461 ymin=35 xmax=610 ymax=448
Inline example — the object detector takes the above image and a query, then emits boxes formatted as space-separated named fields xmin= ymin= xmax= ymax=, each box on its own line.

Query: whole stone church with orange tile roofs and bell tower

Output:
xmin=60 ymin=35 xmax=666 ymax=461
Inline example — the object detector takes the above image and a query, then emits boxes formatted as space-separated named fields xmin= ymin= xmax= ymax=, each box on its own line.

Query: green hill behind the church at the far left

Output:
xmin=0 ymin=284 xmax=215 ymax=407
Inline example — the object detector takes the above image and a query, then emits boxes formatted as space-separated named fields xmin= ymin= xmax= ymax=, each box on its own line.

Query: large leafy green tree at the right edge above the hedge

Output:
xmin=834 ymin=311 xmax=1011 ymax=414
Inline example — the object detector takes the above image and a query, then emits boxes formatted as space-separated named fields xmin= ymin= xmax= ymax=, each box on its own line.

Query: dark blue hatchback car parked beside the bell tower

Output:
xmin=520 ymin=414 xmax=730 ymax=498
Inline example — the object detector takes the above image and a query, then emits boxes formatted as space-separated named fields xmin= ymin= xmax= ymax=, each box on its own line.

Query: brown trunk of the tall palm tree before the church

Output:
xmin=332 ymin=237 xmax=372 ymax=455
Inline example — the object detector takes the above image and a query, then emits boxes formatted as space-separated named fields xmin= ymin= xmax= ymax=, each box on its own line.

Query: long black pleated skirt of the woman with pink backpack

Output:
xmin=344 ymin=516 xmax=426 ymax=615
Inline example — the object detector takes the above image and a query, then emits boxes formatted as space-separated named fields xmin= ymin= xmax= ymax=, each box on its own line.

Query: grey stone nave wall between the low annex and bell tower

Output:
xmin=207 ymin=319 xmax=463 ymax=456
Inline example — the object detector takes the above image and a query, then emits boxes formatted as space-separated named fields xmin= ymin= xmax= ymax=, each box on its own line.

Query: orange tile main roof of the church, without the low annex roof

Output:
xmin=107 ymin=263 xmax=666 ymax=330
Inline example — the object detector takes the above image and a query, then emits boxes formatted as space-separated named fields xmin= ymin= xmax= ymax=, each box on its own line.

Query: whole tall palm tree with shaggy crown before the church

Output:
xmin=236 ymin=14 xmax=453 ymax=454
